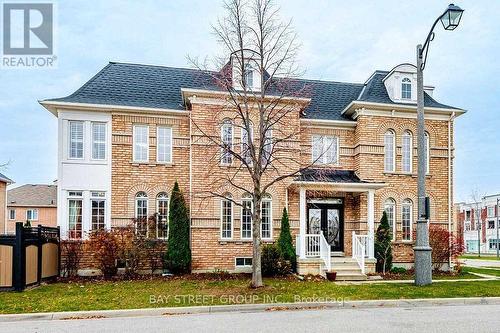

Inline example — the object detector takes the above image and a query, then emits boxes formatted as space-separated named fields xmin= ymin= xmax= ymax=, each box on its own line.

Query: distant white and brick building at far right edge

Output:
xmin=458 ymin=194 xmax=500 ymax=253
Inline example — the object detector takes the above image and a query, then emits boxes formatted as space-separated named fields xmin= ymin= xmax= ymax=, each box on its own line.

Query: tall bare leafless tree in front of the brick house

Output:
xmin=189 ymin=0 xmax=330 ymax=288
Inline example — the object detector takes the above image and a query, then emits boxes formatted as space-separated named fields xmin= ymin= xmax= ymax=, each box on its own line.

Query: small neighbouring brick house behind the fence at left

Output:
xmin=6 ymin=184 xmax=57 ymax=233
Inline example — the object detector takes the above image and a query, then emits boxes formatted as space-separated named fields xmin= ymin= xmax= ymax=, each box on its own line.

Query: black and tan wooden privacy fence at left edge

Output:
xmin=0 ymin=222 xmax=61 ymax=291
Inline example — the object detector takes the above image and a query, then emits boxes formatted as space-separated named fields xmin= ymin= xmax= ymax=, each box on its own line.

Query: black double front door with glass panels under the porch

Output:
xmin=307 ymin=203 xmax=344 ymax=251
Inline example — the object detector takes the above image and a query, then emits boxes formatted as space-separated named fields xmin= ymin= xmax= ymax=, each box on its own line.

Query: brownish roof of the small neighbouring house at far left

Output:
xmin=7 ymin=184 xmax=57 ymax=207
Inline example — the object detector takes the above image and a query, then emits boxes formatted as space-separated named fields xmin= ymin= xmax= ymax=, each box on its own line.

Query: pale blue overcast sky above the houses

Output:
xmin=0 ymin=0 xmax=500 ymax=200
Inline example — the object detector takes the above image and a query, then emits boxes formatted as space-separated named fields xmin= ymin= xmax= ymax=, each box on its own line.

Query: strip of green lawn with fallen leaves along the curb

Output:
xmin=0 ymin=278 xmax=500 ymax=314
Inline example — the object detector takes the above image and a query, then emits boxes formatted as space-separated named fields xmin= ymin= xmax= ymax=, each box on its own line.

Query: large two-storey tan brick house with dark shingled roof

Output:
xmin=40 ymin=62 xmax=464 ymax=274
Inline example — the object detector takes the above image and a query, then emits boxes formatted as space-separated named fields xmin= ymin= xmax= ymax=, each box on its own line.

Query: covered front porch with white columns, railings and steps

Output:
xmin=293 ymin=170 xmax=385 ymax=280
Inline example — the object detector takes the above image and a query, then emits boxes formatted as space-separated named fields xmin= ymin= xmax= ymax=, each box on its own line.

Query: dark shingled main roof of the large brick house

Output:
xmin=47 ymin=62 xmax=458 ymax=120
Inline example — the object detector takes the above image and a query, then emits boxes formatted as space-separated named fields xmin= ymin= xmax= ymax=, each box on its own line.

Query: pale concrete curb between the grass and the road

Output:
xmin=0 ymin=297 xmax=500 ymax=323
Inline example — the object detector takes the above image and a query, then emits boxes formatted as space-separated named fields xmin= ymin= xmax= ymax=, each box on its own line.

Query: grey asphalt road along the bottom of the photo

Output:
xmin=0 ymin=305 xmax=500 ymax=333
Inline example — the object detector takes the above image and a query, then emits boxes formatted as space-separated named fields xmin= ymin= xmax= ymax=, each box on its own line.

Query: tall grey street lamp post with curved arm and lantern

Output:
xmin=413 ymin=4 xmax=463 ymax=286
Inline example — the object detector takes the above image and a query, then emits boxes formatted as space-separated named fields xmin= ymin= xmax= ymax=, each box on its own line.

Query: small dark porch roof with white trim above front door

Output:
xmin=292 ymin=169 xmax=386 ymax=192
